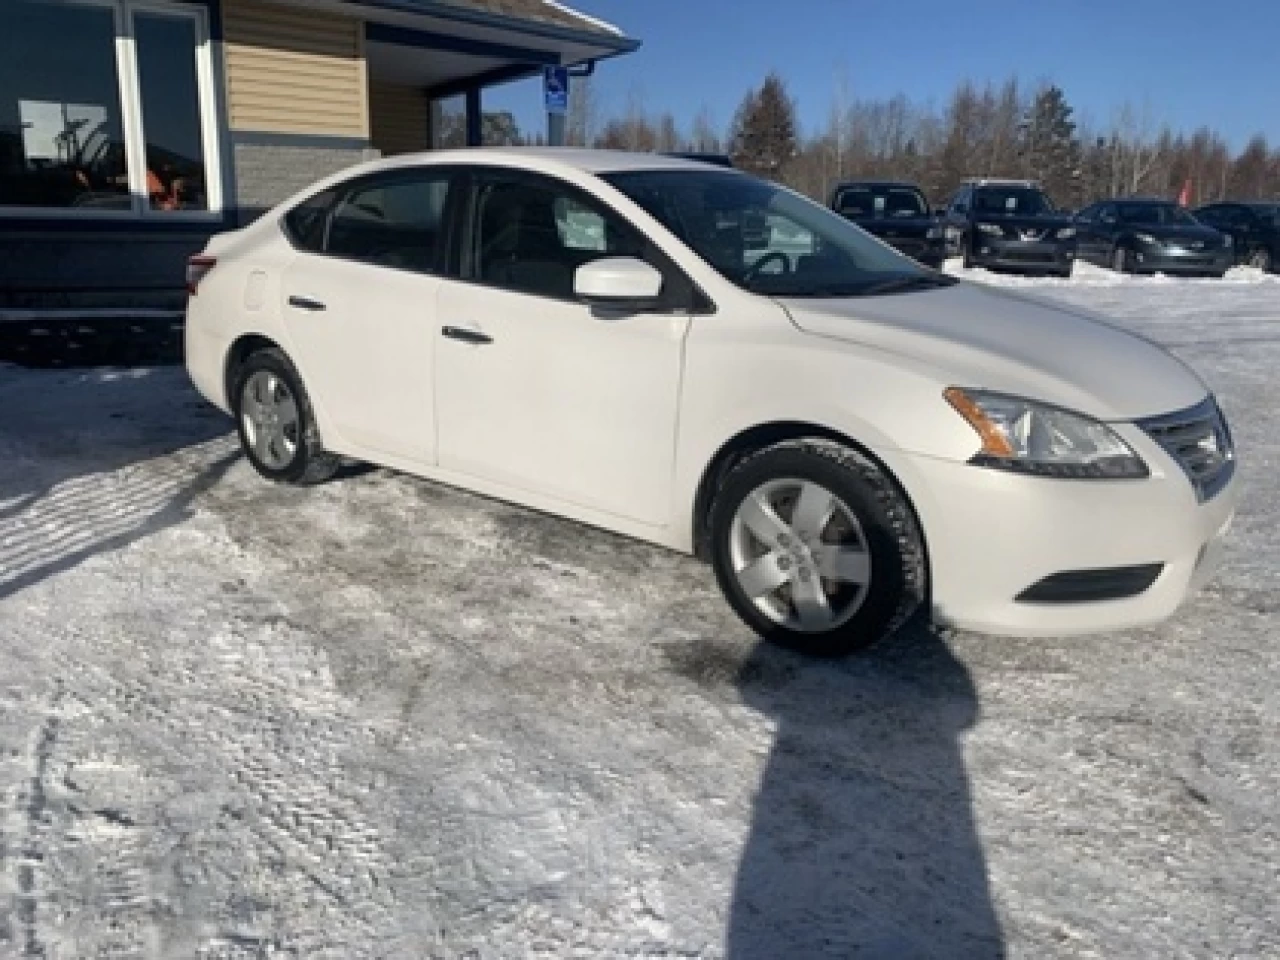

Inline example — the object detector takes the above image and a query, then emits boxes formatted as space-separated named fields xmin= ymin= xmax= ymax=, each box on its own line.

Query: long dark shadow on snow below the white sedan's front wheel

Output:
xmin=726 ymin=622 xmax=1005 ymax=960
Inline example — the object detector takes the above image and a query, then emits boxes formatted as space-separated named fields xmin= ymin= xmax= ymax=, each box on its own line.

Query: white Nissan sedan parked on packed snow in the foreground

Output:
xmin=186 ymin=150 xmax=1236 ymax=654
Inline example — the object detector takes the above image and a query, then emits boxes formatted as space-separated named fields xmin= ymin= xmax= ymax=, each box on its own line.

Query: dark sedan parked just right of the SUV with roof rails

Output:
xmin=1075 ymin=200 xmax=1235 ymax=276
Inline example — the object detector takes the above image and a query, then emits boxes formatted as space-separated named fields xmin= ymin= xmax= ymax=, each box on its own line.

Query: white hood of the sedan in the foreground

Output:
xmin=780 ymin=283 xmax=1208 ymax=420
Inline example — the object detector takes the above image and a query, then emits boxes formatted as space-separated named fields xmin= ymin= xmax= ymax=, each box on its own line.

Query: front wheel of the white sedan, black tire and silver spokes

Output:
xmin=708 ymin=439 xmax=928 ymax=657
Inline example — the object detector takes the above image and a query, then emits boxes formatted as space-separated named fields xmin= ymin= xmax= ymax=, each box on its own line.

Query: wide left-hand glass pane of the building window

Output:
xmin=0 ymin=0 xmax=131 ymax=210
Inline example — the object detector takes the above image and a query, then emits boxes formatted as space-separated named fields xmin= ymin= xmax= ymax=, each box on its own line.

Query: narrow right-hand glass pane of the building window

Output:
xmin=133 ymin=13 xmax=209 ymax=210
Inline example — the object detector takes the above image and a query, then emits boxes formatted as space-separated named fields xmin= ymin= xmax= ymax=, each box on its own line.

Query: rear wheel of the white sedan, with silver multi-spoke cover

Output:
xmin=232 ymin=347 xmax=342 ymax=485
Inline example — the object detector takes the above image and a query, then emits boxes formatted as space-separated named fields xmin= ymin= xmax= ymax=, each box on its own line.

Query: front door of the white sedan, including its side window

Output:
xmin=435 ymin=170 xmax=692 ymax=526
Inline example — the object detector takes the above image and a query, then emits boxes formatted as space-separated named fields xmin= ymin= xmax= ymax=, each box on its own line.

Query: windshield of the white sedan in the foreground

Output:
xmin=602 ymin=168 xmax=951 ymax=297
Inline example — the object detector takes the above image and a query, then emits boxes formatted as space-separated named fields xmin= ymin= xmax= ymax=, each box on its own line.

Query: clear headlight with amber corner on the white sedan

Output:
xmin=943 ymin=387 xmax=1151 ymax=480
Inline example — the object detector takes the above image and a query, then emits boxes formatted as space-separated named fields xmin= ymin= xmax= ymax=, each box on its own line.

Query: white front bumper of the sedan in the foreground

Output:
xmin=904 ymin=428 xmax=1239 ymax=636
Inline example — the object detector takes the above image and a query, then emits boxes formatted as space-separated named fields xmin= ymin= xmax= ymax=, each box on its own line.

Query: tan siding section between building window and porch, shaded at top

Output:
xmin=223 ymin=0 xmax=369 ymax=137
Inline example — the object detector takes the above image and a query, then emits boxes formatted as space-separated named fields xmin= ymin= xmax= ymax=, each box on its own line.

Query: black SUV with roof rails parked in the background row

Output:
xmin=943 ymin=179 xmax=1075 ymax=276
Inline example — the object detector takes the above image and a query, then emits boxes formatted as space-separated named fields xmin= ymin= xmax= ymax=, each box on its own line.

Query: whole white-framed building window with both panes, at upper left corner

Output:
xmin=0 ymin=0 xmax=220 ymax=216
